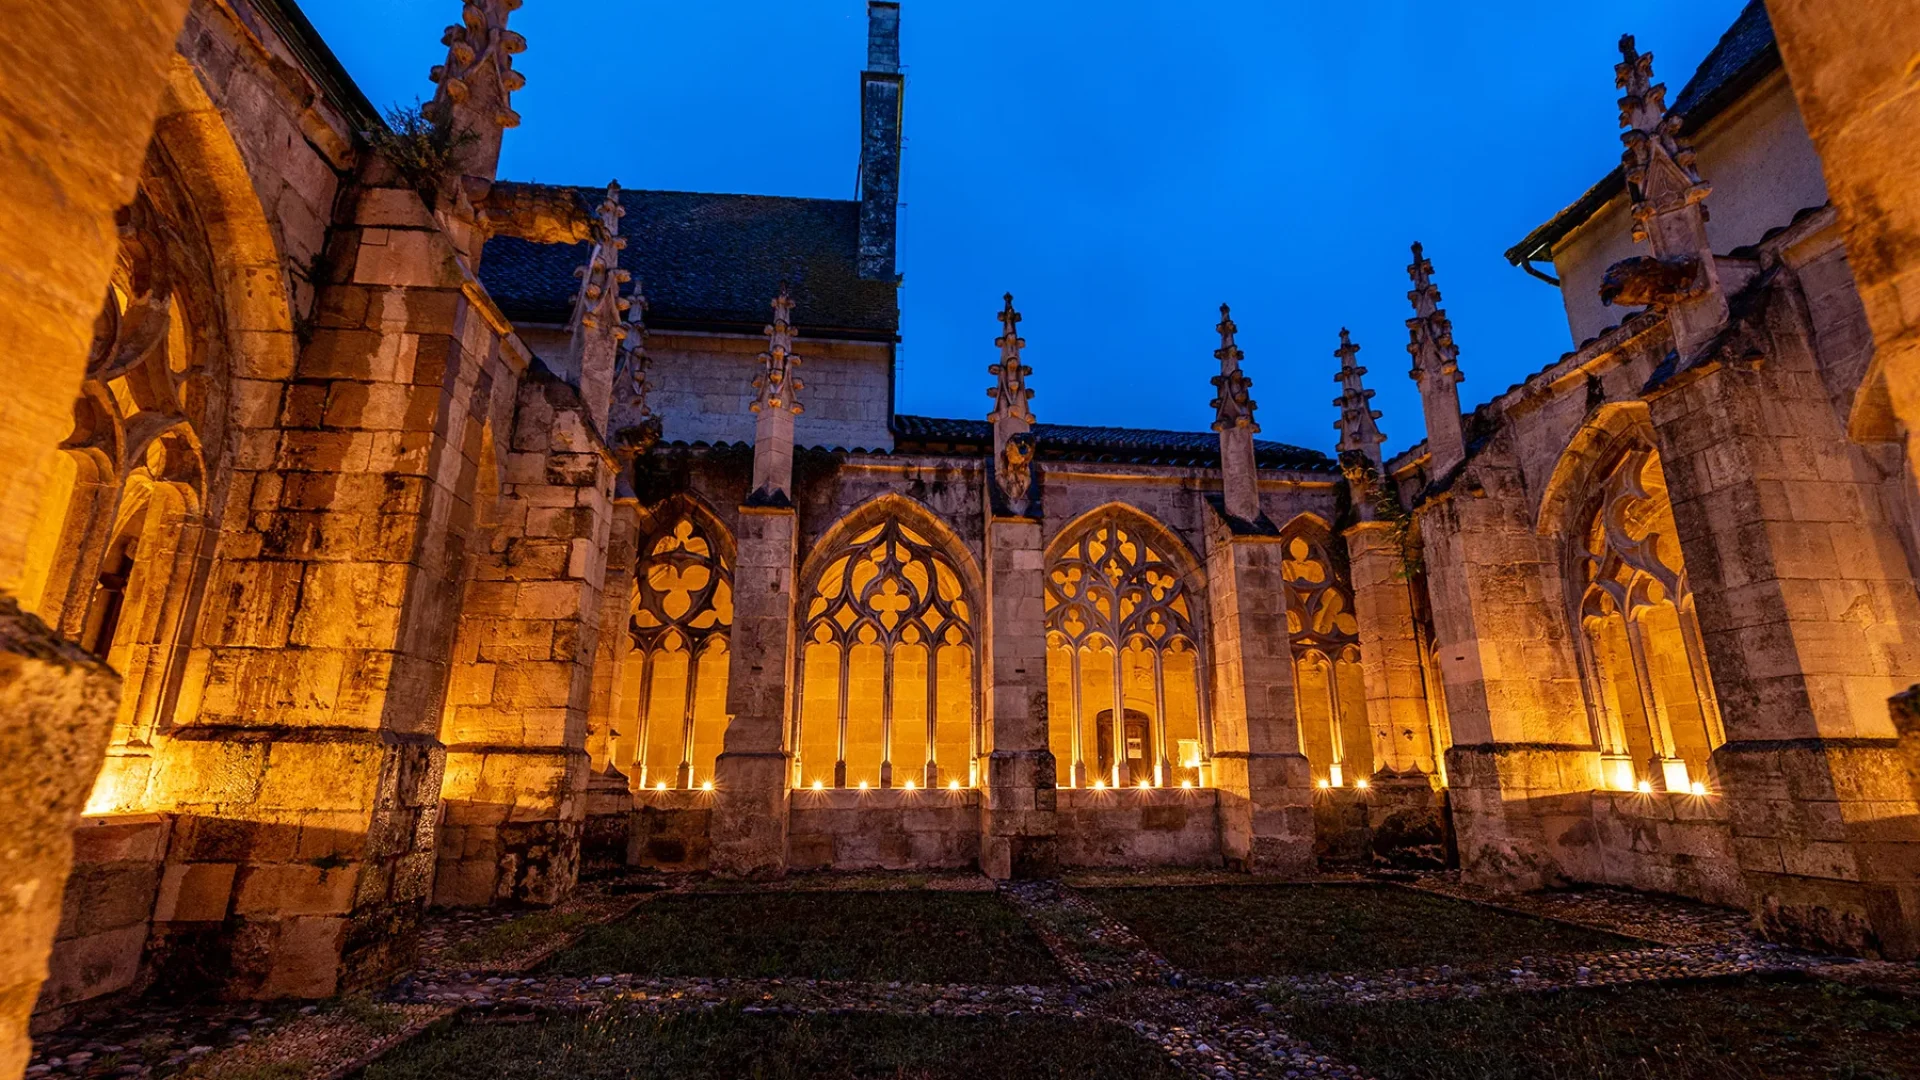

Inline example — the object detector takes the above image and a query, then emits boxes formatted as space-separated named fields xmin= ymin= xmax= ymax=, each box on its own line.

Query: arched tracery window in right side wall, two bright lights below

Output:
xmin=1569 ymin=446 xmax=1726 ymax=792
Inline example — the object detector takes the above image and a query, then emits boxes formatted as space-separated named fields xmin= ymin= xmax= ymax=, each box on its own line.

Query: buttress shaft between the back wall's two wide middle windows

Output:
xmin=979 ymin=515 xmax=1058 ymax=880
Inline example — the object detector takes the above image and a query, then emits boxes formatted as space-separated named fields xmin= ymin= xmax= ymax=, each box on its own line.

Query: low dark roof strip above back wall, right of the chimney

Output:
xmin=893 ymin=415 xmax=1340 ymax=473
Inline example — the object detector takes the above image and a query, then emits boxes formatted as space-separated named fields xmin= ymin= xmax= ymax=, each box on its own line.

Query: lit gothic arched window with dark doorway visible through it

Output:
xmin=1046 ymin=509 xmax=1212 ymax=788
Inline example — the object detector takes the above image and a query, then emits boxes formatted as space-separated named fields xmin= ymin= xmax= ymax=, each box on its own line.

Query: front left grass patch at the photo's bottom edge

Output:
xmin=361 ymin=1009 xmax=1181 ymax=1080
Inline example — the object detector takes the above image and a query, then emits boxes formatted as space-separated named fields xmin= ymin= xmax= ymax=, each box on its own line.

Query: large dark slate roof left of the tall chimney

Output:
xmin=480 ymin=188 xmax=900 ymax=342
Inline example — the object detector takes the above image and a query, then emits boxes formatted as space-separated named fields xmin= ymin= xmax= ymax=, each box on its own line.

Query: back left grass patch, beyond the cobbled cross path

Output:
xmin=551 ymin=892 xmax=1060 ymax=984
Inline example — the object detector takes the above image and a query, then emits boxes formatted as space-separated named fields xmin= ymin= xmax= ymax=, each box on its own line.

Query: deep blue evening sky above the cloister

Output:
xmin=301 ymin=0 xmax=1741 ymax=452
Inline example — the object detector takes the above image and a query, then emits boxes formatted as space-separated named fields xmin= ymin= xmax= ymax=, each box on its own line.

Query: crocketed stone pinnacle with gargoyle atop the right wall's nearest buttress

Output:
xmin=1599 ymin=35 xmax=1728 ymax=361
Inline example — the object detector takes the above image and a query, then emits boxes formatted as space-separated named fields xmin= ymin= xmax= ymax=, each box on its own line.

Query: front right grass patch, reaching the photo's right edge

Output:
xmin=1283 ymin=978 xmax=1920 ymax=1080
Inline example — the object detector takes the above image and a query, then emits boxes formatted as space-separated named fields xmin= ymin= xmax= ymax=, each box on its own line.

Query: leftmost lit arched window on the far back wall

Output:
xmin=628 ymin=513 xmax=733 ymax=788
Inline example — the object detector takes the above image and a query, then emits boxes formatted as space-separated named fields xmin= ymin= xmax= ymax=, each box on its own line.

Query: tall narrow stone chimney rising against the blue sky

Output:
xmin=860 ymin=0 xmax=906 ymax=281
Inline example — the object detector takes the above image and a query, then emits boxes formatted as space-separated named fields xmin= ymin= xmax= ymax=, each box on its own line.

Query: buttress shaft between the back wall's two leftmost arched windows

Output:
xmin=708 ymin=503 xmax=799 ymax=878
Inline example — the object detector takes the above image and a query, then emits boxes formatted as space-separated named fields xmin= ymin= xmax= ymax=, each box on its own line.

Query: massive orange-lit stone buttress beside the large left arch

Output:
xmin=148 ymin=174 xmax=491 ymax=997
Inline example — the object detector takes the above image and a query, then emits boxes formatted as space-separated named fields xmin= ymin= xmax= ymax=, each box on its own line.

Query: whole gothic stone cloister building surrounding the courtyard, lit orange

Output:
xmin=0 ymin=0 xmax=1920 ymax=1078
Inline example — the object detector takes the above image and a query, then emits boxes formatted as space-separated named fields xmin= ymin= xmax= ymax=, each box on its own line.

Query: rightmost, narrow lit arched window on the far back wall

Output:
xmin=1281 ymin=523 xmax=1373 ymax=788
